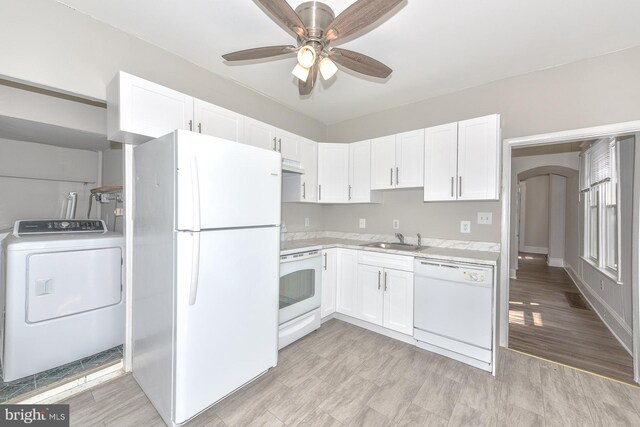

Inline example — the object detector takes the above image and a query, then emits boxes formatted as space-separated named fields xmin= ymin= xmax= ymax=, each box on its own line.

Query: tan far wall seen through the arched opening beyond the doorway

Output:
xmin=521 ymin=175 xmax=549 ymax=254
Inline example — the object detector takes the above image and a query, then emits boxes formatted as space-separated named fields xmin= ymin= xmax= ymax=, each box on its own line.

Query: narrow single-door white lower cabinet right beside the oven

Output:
xmin=336 ymin=249 xmax=359 ymax=317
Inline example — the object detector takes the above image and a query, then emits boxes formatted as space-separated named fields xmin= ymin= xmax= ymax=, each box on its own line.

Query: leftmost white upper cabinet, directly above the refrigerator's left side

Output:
xmin=107 ymin=71 xmax=193 ymax=144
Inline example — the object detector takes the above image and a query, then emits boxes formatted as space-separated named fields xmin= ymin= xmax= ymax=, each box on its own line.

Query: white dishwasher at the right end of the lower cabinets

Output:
xmin=414 ymin=258 xmax=493 ymax=372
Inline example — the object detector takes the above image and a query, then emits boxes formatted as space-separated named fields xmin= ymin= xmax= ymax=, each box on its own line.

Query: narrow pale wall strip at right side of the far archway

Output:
xmin=548 ymin=175 xmax=567 ymax=267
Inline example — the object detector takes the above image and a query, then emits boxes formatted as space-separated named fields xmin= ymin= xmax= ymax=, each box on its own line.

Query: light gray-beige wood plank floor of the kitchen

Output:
xmin=63 ymin=320 xmax=640 ymax=427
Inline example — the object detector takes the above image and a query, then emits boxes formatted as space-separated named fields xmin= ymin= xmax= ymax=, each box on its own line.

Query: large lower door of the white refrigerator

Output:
xmin=174 ymin=227 xmax=280 ymax=424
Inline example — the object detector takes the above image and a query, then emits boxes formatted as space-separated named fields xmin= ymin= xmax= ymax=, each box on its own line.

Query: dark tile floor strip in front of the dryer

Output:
xmin=0 ymin=346 xmax=122 ymax=403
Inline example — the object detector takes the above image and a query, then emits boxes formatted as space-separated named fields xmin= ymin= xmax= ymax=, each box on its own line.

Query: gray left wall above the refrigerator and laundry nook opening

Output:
xmin=0 ymin=0 xmax=326 ymax=141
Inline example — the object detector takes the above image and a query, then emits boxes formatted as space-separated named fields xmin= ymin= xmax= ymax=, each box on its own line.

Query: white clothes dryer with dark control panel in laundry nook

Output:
xmin=0 ymin=220 xmax=125 ymax=382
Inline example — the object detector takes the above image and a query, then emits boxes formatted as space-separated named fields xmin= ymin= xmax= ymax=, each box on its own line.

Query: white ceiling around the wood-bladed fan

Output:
xmin=59 ymin=0 xmax=640 ymax=124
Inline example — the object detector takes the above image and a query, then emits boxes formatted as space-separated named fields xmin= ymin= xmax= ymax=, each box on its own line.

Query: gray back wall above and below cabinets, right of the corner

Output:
xmin=325 ymin=47 xmax=640 ymax=242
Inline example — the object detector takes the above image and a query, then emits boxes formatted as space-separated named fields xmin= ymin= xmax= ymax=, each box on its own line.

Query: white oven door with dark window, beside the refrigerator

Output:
xmin=279 ymin=252 xmax=322 ymax=324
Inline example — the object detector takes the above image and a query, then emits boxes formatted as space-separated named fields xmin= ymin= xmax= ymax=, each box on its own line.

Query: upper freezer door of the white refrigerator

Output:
xmin=175 ymin=131 xmax=282 ymax=231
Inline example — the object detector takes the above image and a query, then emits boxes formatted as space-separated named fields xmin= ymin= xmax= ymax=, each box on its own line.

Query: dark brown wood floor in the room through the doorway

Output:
xmin=509 ymin=253 xmax=633 ymax=383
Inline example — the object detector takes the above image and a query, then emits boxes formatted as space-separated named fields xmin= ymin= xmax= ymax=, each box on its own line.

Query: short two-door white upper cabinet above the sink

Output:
xmin=371 ymin=129 xmax=424 ymax=190
